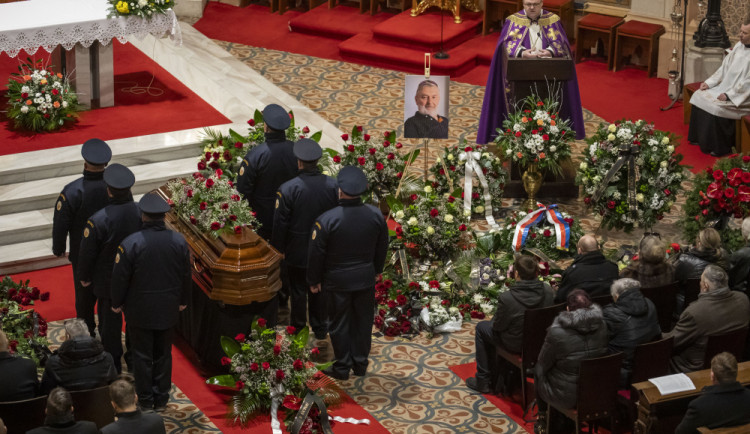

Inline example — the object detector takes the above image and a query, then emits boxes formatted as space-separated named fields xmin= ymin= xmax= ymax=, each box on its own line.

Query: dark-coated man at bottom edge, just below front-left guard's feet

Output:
xmin=102 ymin=379 xmax=166 ymax=434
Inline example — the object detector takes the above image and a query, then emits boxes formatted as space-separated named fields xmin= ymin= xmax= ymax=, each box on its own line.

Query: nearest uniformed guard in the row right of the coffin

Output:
xmin=307 ymin=166 xmax=388 ymax=380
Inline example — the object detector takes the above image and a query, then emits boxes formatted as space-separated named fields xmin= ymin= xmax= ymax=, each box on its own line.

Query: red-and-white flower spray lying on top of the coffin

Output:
xmin=167 ymin=169 xmax=260 ymax=237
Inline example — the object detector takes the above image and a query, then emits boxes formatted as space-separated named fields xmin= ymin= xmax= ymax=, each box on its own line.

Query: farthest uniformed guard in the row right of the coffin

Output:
xmin=237 ymin=104 xmax=297 ymax=240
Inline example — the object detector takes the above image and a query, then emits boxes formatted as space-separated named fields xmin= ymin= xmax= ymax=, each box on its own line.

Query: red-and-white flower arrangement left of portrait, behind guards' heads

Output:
xmin=336 ymin=126 xmax=419 ymax=201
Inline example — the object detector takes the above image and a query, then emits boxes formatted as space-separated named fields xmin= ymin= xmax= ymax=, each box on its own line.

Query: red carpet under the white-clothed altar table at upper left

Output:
xmin=0 ymin=42 xmax=230 ymax=155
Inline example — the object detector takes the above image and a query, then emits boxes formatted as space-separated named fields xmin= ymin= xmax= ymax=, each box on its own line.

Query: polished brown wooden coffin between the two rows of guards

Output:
xmin=157 ymin=186 xmax=283 ymax=306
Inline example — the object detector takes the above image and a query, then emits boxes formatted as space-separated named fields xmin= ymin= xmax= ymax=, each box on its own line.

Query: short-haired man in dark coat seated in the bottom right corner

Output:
xmin=675 ymin=353 xmax=750 ymax=434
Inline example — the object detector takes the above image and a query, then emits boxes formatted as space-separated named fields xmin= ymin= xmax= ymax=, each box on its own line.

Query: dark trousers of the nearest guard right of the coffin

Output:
xmin=328 ymin=287 xmax=375 ymax=375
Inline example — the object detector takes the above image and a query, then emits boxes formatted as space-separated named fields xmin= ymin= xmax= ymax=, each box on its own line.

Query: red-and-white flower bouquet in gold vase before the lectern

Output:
xmin=495 ymin=95 xmax=575 ymax=176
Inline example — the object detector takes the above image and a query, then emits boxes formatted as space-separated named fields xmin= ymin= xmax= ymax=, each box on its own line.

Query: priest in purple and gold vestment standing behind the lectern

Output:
xmin=477 ymin=0 xmax=586 ymax=144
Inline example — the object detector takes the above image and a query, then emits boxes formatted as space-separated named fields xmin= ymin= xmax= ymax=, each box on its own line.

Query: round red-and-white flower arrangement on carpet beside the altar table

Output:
xmin=6 ymin=58 xmax=79 ymax=132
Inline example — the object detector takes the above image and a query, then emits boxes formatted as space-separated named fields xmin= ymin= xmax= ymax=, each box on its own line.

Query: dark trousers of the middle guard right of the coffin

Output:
xmin=287 ymin=266 xmax=328 ymax=338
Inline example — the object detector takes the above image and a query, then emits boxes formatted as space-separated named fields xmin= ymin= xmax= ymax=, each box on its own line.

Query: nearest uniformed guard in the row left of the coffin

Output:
xmin=111 ymin=193 xmax=192 ymax=412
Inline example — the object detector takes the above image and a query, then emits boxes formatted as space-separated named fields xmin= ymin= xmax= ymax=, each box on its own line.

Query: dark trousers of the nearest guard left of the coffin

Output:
xmin=128 ymin=324 xmax=172 ymax=409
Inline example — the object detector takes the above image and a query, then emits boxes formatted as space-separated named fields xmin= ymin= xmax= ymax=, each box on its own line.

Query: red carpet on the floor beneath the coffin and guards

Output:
xmin=11 ymin=265 xmax=388 ymax=434
